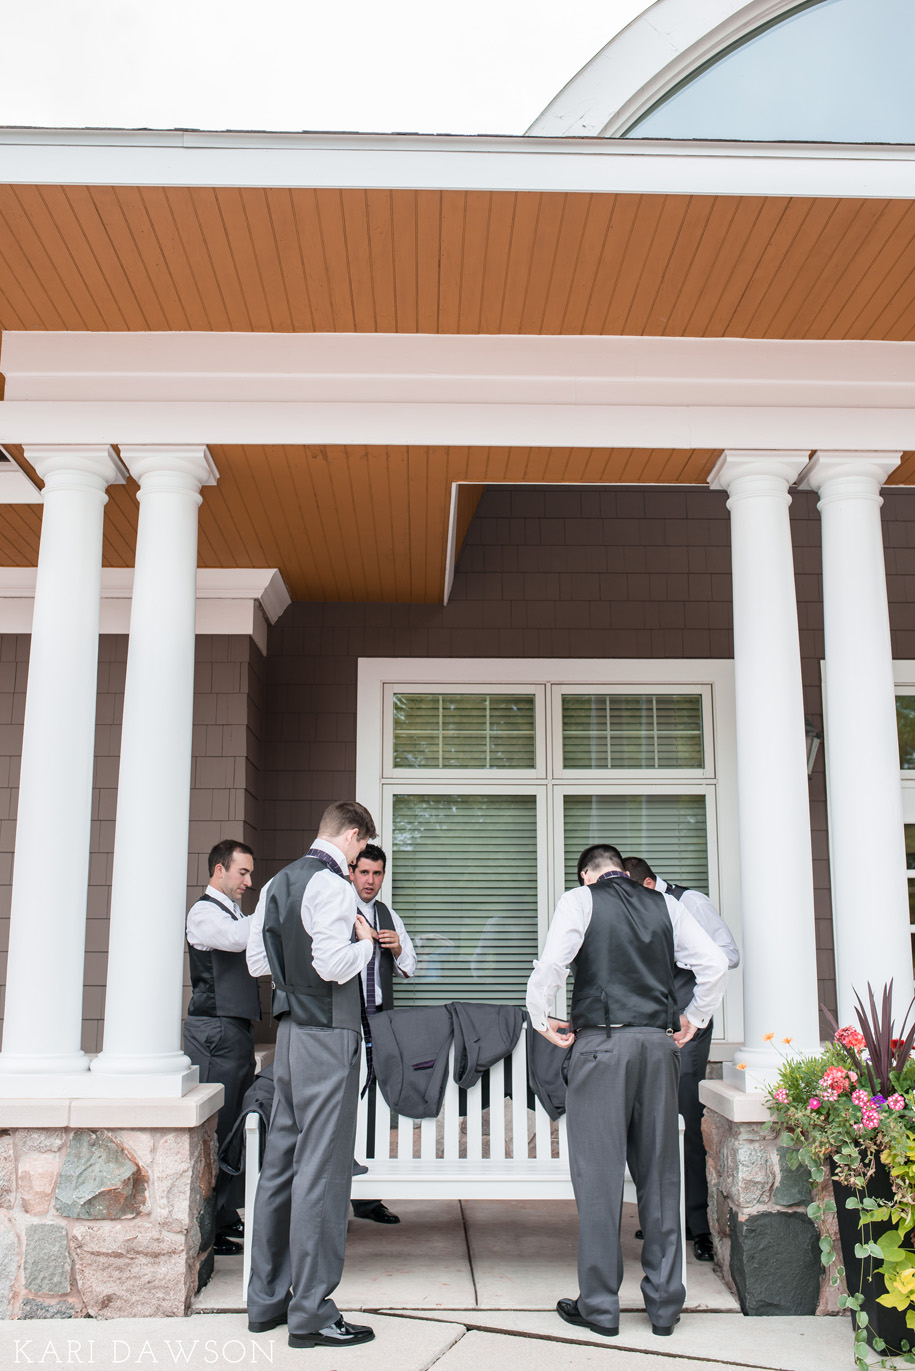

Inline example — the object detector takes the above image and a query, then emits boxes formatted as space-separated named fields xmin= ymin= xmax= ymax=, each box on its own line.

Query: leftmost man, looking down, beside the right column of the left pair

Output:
xmin=184 ymin=838 xmax=261 ymax=1256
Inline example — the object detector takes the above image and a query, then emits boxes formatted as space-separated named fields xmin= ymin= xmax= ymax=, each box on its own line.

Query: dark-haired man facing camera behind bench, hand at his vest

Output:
xmin=350 ymin=843 xmax=416 ymax=1223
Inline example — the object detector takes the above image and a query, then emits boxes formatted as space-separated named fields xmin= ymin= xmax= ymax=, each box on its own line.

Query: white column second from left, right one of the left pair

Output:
xmin=92 ymin=446 xmax=218 ymax=1094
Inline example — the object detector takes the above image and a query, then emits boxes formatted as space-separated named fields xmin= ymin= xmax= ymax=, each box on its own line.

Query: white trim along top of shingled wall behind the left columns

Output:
xmin=0 ymin=566 xmax=291 ymax=651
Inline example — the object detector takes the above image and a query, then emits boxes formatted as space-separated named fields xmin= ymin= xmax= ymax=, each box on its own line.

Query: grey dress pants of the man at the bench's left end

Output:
xmin=247 ymin=1015 xmax=362 ymax=1334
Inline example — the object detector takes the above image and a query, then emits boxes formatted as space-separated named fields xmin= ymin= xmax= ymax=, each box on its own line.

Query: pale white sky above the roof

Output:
xmin=0 ymin=0 xmax=650 ymax=133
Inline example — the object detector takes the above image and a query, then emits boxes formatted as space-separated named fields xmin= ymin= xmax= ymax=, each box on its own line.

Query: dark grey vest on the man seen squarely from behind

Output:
xmin=572 ymin=876 xmax=680 ymax=1035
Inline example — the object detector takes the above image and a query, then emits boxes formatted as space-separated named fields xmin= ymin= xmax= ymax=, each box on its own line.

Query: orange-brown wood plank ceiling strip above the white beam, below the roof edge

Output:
xmin=0 ymin=185 xmax=915 ymax=341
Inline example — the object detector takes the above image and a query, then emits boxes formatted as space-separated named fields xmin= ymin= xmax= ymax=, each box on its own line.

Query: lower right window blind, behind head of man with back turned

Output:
xmin=564 ymin=795 xmax=709 ymax=894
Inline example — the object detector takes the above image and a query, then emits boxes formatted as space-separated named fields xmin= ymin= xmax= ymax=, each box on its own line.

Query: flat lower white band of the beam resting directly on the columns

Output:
xmin=0 ymin=400 xmax=915 ymax=451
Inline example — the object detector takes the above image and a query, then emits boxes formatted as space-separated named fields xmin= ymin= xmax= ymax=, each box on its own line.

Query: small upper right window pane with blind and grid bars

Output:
xmin=562 ymin=694 xmax=704 ymax=771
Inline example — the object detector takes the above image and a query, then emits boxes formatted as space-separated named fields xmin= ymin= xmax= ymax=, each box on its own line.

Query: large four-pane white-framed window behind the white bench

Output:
xmin=357 ymin=659 xmax=739 ymax=1041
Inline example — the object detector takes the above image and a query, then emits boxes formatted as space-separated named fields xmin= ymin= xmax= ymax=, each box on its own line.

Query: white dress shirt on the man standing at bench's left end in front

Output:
xmin=248 ymin=838 xmax=375 ymax=986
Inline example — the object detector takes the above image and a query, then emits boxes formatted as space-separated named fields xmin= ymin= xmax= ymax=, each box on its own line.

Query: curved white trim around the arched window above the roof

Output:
xmin=527 ymin=0 xmax=823 ymax=138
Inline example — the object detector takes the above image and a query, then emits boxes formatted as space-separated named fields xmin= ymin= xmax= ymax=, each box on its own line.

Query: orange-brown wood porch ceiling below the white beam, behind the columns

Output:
xmin=0 ymin=447 xmax=717 ymax=603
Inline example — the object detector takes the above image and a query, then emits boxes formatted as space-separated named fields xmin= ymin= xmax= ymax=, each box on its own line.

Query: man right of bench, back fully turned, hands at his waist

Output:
xmin=527 ymin=843 xmax=727 ymax=1337
